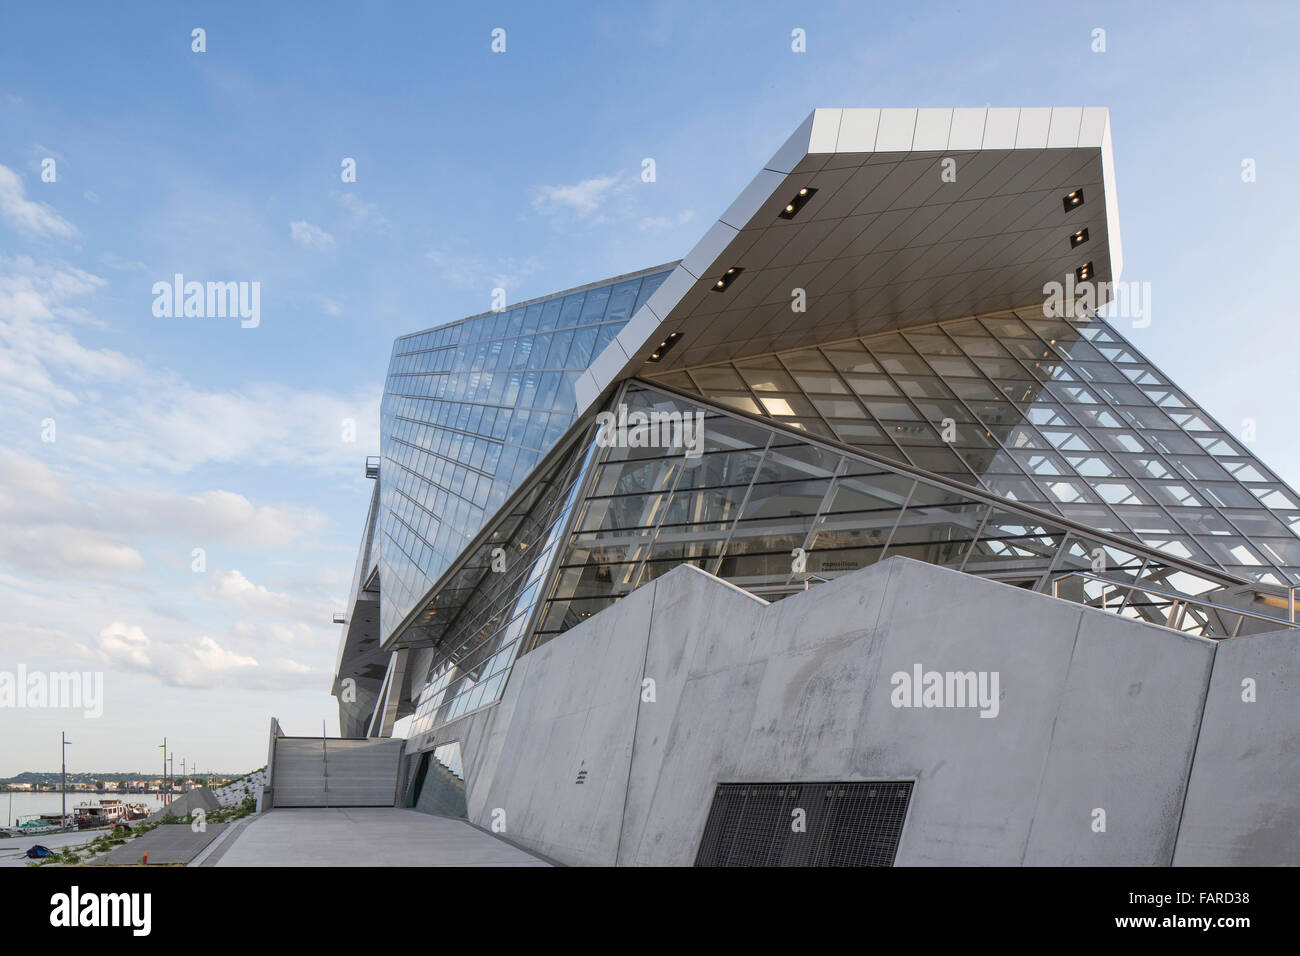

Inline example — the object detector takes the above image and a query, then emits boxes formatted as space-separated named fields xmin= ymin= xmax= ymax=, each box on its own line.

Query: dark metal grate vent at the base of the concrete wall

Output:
xmin=696 ymin=780 xmax=911 ymax=866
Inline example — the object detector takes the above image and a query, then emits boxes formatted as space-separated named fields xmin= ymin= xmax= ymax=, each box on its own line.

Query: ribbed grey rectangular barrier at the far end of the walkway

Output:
xmin=272 ymin=737 xmax=406 ymax=808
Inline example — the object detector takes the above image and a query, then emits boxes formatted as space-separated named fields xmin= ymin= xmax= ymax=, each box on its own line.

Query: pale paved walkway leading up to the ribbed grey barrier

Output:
xmin=210 ymin=806 xmax=550 ymax=866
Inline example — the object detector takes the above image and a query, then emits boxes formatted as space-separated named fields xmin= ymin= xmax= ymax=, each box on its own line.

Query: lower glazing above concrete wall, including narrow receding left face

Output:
xmin=400 ymin=380 xmax=1294 ymax=748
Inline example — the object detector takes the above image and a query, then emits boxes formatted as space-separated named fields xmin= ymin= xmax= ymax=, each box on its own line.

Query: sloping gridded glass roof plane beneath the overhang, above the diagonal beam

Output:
xmin=653 ymin=312 xmax=1300 ymax=584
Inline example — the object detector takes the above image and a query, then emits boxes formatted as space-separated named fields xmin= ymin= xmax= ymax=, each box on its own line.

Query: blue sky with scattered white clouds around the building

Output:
xmin=0 ymin=3 xmax=1300 ymax=775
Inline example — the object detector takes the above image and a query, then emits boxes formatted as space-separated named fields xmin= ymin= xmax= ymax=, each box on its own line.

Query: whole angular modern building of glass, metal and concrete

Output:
xmin=322 ymin=108 xmax=1300 ymax=865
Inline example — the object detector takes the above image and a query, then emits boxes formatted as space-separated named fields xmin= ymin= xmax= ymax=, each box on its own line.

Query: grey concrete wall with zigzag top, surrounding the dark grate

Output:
xmin=423 ymin=558 xmax=1297 ymax=865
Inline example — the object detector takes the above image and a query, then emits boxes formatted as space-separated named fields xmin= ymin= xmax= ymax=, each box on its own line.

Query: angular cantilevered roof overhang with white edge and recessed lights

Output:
xmin=577 ymin=107 xmax=1122 ymax=410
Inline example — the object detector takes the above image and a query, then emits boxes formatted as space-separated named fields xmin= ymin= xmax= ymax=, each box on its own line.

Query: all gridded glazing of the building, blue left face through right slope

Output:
xmin=378 ymin=287 xmax=1300 ymax=749
